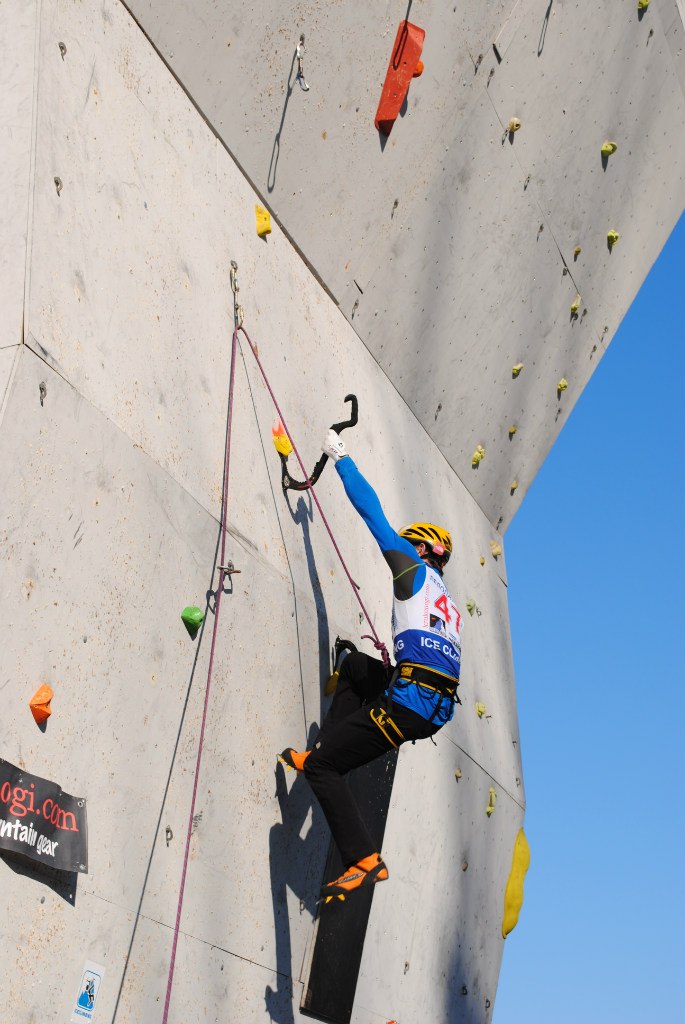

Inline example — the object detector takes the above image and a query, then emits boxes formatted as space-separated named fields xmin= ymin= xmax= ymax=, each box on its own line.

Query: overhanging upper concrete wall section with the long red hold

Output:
xmin=122 ymin=0 xmax=685 ymax=529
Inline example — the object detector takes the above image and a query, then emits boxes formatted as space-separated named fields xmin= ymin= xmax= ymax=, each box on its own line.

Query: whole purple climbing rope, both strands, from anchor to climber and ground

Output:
xmin=162 ymin=260 xmax=390 ymax=1024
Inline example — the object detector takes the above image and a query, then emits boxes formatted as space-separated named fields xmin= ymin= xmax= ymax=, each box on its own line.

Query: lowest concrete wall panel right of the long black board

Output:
xmin=352 ymin=733 xmax=522 ymax=1024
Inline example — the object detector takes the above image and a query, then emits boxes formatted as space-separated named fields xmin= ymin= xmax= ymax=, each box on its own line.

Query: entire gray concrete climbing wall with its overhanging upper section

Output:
xmin=0 ymin=0 xmax=685 ymax=1024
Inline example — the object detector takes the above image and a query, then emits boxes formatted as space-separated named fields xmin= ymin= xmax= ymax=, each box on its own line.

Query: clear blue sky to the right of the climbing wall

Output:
xmin=494 ymin=209 xmax=685 ymax=1024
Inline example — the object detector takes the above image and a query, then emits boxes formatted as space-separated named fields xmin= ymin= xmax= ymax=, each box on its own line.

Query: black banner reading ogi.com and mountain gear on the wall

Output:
xmin=0 ymin=758 xmax=88 ymax=871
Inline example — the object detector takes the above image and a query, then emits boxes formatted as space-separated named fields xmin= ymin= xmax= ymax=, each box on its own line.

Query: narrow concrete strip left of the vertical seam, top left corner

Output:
xmin=0 ymin=0 xmax=38 ymax=349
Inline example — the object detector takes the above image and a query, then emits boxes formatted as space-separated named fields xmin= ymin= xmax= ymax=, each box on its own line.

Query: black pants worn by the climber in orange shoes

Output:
xmin=304 ymin=653 xmax=440 ymax=867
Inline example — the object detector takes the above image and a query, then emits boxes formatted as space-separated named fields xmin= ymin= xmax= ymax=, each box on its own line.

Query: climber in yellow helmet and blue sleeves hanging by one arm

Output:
xmin=281 ymin=430 xmax=462 ymax=900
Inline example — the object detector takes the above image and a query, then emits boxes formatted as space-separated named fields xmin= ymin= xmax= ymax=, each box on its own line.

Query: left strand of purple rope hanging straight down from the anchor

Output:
xmin=162 ymin=327 xmax=238 ymax=1024
